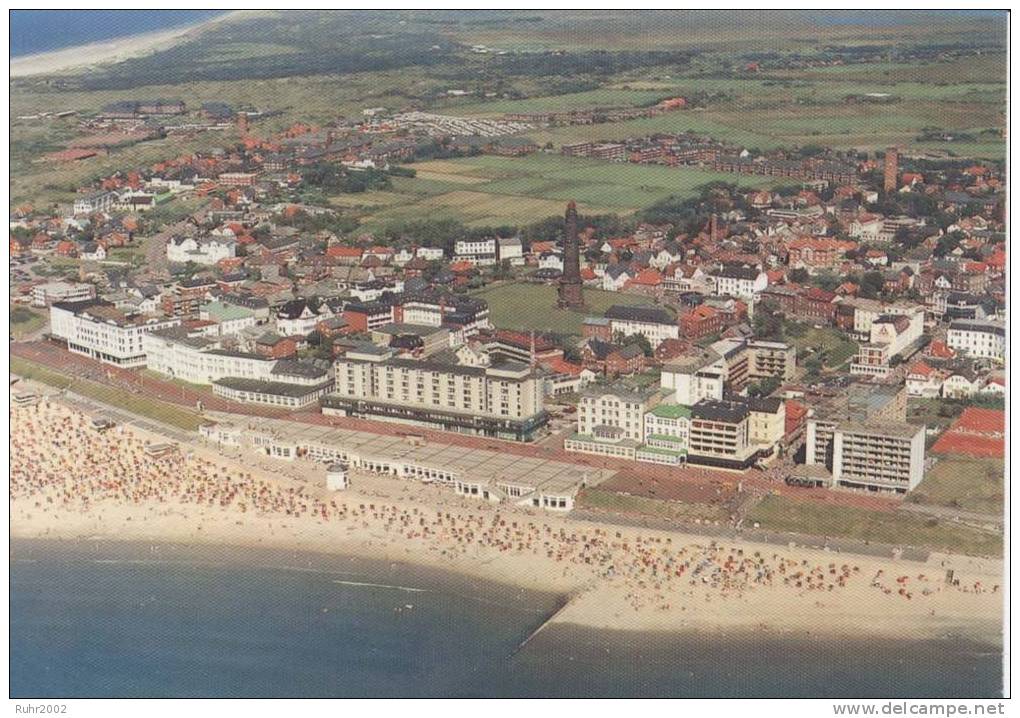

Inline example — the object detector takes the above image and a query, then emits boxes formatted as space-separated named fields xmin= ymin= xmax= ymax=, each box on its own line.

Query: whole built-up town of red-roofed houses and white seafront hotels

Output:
xmin=10 ymin=92 xmax=1007 ymax=501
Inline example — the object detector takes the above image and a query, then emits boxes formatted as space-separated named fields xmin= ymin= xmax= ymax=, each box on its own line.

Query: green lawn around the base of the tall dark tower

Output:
xmin=473 ymin=283 xmax=653 ymax=336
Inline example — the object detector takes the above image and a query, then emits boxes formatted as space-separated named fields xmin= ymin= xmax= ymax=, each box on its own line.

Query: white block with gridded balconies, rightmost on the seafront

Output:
xmin=832 ymin=422 xmax=925 ymax=494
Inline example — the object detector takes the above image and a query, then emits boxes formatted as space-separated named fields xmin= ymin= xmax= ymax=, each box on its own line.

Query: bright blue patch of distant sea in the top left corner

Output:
xmin=9 ymin=10 xmax=226 ymax=58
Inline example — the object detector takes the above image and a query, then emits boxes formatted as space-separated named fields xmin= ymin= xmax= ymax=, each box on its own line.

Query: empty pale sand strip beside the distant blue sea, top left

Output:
xmin=10 ymin=10 xmax=252 ymax=78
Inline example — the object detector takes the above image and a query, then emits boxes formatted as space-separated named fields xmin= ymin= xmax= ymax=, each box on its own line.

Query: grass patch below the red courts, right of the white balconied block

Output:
xmin=910 ymin=456 xmax=1005 ymax=514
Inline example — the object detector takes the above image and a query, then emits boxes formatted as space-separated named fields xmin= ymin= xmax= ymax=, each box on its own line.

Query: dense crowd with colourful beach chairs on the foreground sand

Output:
xmin=10 ymin=399 xmax=999 ymax=640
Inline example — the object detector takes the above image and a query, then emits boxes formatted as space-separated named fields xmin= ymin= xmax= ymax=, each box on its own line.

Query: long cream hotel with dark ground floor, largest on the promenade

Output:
xmin=322 ymin=345 xmax=548 ymax=441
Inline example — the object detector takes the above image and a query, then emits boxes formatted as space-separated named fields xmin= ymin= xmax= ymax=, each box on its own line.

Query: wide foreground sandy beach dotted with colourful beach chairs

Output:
xmin=10 ymin=401 xmax=1003 ymax=644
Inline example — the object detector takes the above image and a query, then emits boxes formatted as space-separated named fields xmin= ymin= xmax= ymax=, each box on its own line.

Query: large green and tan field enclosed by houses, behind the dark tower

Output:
xmin=359 ymin=153 xmax=774 ymax=228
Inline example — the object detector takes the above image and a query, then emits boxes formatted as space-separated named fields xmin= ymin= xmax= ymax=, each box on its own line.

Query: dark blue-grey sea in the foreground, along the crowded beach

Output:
xmin=10 ymin=542 xmax=1002 ymax=698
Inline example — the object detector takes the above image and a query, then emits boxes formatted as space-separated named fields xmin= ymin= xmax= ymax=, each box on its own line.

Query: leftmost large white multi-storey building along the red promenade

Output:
xmin=50 ymin=300 xmax=181 ymax=366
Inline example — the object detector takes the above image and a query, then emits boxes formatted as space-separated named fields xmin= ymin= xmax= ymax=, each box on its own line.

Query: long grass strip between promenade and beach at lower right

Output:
xmin=747 ymin=496 xmax=1003 ymax=556
